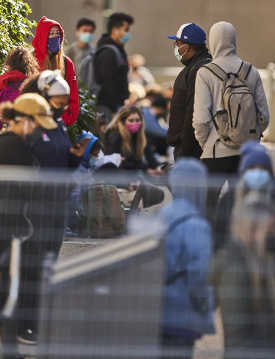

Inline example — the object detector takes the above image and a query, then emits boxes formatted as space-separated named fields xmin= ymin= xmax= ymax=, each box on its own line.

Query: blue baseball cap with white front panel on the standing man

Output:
xmin=168 ymin=24 xmax=206 ymax=45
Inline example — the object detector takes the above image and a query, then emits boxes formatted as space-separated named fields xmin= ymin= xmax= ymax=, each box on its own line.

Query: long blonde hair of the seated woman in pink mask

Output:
xmin=107 ymin=106 xmax=147 ymax=160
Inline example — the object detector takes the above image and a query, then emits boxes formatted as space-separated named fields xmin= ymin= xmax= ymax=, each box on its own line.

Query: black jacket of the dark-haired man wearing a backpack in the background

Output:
xmin=94 ymin=35 xmax=129 ymax=113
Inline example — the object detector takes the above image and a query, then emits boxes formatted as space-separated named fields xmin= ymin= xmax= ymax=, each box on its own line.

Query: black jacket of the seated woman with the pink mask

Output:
xmin=104 ymin=130 xmax=158 ymax=170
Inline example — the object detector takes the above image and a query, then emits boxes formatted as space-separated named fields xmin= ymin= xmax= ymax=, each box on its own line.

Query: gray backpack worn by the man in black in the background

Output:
xmin=79 ymin=45 xmax=124 ymax=95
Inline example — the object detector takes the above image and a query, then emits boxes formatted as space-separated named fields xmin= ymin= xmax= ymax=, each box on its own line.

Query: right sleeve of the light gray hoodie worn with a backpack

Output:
xmin=254 ymin=69 xmax=270 ymax=131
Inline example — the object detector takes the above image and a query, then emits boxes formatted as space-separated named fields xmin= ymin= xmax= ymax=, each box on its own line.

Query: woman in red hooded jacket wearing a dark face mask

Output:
xmin=32 ymin=16 xmax=79 ymax=126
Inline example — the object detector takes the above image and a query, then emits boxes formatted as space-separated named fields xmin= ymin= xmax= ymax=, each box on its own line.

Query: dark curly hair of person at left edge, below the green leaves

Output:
xmin=4 ymin=46 xmax=39 ymax=77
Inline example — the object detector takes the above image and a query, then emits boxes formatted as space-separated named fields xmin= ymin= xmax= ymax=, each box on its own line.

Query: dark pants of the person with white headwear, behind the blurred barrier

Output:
xmin=17 ymin=183 xmax=68 ymax=332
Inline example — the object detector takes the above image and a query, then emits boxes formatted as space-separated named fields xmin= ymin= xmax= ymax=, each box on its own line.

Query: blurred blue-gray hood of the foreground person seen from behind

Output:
xmin=169 ymin=159 xmax=207 ymax=214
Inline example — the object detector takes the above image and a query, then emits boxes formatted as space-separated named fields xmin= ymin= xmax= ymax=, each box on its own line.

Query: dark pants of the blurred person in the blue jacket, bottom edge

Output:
xmin=161 ymin=335 xmax=195 ymax=359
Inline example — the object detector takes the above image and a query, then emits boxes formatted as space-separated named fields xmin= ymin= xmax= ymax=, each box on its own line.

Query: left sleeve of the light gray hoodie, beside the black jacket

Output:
xmin=193 ymin=69 xmax=212 ymax=149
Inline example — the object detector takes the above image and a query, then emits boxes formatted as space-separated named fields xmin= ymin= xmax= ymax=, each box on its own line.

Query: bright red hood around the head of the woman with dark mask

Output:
xmin=32 ymin=16 xmax=64 ymax=70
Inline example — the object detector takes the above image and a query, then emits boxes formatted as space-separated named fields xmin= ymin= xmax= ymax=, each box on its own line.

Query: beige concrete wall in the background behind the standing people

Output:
xmin=26 ymin=0 xmax=275 ymax=68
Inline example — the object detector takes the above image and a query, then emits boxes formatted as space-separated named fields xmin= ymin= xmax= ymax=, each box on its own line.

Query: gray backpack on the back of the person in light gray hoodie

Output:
xmin=204 ymin=62 xmax=264 ymax=149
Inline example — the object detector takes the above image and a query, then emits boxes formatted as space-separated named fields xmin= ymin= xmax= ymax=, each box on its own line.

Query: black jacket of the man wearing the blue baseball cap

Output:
xmin=167 ymin=49 xmax=212 ymax=158
